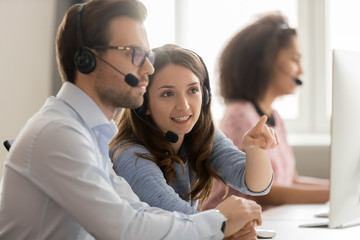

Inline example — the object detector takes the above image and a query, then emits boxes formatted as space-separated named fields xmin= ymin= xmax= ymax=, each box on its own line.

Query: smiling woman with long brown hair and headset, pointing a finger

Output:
xmin=110 ymin=44 xmax=278 ymax=238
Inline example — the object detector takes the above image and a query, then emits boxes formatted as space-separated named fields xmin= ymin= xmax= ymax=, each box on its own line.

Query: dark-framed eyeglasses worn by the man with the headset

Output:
xmin=90 ymin=45 xmax=155 ymax=67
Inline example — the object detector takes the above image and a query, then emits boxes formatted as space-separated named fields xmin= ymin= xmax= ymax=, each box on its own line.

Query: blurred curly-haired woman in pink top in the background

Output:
xmin=204 ymin=13 xmax=329 ymax=212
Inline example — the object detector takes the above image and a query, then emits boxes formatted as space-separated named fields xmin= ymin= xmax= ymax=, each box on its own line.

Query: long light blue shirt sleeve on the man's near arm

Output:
xmin=9 ymin=122 xmax=225 ymax=240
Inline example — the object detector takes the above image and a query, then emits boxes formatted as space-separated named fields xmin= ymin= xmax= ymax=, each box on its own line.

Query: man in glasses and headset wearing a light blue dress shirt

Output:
xmin=0 ymin=0 xmax=262 ymax=239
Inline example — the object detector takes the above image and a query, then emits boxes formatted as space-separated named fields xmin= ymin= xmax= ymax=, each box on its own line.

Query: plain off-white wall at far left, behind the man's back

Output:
xmin=0 ymin=0 xmax=56 ymax=176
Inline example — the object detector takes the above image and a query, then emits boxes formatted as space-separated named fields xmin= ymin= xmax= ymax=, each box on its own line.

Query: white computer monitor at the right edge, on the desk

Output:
xmin=328 ymin=49 xmax=360 ymax=228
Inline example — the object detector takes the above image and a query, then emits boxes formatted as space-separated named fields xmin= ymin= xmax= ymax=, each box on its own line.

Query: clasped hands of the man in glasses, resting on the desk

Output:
xmin=215 ymin=196 xmax=262 ymax=239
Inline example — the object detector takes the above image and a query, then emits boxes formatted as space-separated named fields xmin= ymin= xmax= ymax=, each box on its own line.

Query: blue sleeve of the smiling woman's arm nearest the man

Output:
xmin=114 ymin=145 xmax=197 ymax=214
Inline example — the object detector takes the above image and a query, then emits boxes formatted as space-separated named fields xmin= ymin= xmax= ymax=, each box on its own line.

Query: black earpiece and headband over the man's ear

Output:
xmin=74 ymin=3 xmax=96 ymax=74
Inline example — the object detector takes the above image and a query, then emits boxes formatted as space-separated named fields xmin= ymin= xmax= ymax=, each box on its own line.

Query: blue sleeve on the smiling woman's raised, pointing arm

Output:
xmin=209 ymin=129 xmax=271 ymax=196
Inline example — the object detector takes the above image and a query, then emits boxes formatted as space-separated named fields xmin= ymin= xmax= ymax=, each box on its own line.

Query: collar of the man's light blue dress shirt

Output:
xmin=57 ymin=82 xmax=117 ymax=137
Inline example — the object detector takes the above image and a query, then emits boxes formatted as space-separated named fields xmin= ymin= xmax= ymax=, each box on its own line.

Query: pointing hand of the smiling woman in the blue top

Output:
xmin=242 ymin=115 xmax=279 ymax=151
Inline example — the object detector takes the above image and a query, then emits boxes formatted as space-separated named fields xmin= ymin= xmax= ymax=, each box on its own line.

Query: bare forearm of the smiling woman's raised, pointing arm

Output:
xmin=245 ymin=148 xmax=273 ymax=192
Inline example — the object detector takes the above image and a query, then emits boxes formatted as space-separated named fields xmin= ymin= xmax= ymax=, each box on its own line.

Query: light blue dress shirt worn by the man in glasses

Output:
xmin=0 ymin=82 xmax=225 ymax=240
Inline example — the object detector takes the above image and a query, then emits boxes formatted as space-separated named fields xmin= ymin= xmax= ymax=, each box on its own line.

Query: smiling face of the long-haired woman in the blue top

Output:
xmin=147 ymin=64 xmax=202 ymax=142
